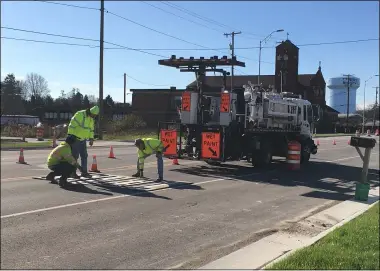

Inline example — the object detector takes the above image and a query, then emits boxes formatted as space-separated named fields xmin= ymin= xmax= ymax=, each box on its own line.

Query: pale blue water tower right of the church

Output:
xmin=326 ymin=76 xmax=360 ymax=114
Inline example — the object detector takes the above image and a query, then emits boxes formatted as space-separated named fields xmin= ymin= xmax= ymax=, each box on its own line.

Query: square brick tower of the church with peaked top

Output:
xmin=275 ymin=39 xmax=302 ymax=94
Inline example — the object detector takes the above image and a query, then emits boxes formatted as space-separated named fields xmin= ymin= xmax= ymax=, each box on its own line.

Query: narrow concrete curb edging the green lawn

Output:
xmin=260 ymin=190 xmax=379 ymax=269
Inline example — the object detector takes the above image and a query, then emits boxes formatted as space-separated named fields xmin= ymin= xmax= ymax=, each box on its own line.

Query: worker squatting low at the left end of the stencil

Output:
xmin=46 ymin=135 xmax=83 ymax=186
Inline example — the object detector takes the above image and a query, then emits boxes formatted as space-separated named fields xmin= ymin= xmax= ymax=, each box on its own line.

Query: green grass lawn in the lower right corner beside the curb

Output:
xmin=266 ymin=203 xmax=380 ymax=270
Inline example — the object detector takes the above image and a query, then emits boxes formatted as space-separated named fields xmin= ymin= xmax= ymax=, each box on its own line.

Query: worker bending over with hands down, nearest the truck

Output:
xmin=132 ymin=138 xmax=164 ymax=182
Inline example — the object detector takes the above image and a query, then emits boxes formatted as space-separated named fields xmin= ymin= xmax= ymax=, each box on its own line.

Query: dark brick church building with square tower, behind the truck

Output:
xmin=131 ymin=40 xmax=338 ymax=132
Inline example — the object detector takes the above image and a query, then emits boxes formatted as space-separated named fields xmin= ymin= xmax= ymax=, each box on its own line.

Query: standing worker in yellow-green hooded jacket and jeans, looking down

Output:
xmin=67 ymin=105 xmax=99 ymax=178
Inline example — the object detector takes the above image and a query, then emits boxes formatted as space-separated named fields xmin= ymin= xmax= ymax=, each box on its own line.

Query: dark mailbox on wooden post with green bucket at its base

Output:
xmin=350 ymin=136 xmax=376 ymax=201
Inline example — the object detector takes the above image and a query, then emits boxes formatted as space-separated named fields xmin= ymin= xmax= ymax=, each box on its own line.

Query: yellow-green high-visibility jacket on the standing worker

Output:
xmin=67 ymin=110 xmax=94 ymax=140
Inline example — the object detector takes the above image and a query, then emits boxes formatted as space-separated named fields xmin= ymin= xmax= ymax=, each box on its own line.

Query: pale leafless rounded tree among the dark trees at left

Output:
xmin=23 ymin=73 xmax=50 ymax=99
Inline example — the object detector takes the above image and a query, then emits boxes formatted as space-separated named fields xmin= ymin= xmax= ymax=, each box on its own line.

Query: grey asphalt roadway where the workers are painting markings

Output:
xmin=1 ymin=137 xmax=379 ymax=269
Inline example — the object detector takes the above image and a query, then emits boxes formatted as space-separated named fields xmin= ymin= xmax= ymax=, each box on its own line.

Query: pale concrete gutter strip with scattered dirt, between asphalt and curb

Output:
xmin=200 ymin=187 xmax=379 ymax=270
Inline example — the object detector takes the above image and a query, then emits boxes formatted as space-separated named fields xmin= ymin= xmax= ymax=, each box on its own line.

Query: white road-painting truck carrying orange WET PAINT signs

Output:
xmin=158 ymin=55 xmax=320 ymax=166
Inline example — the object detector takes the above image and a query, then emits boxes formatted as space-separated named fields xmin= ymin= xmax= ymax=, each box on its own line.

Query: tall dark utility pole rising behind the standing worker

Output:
xmin=98 ymin=0 xmax=104 ymax=139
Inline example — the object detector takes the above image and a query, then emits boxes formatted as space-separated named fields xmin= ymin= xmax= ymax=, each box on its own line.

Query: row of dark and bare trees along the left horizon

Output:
xmin=1 ymin=73 xmax=129 ymax=117
